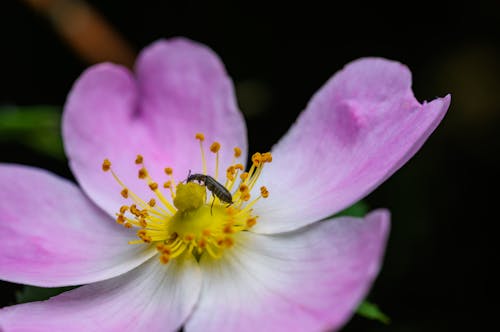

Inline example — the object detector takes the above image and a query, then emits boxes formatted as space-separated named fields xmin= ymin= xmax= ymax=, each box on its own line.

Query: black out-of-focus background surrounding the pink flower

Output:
xmin=0 ymin=0 xmax=500 ymax=331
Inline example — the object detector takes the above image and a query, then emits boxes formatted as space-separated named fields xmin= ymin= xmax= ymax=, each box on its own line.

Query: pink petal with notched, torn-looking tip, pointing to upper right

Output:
xmin=255 ymin=58 xmax=450 ymax=233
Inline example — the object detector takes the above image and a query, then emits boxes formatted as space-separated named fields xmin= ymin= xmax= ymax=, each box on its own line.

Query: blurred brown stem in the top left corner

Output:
xmin=22 ymin=0 xmax=135 ymax=68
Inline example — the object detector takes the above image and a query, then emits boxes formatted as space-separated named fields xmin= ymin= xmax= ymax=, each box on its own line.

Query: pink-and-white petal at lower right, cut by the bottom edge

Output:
xmin=185 ymin=210 xmax=389 ymax=332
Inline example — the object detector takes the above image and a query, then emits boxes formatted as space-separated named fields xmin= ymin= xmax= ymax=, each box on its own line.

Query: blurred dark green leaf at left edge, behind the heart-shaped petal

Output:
xmin=0 ymin=106 xmax=65 ymax=159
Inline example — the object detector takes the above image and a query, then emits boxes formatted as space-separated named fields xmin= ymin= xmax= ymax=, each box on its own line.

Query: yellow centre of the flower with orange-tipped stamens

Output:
xmin=102 ymin=133 xmax=272 ymax=264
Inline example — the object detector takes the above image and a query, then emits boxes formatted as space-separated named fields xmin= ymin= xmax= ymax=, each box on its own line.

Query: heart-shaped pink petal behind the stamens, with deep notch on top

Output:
xmin=63 ymin=39 xmax=247 ymax=214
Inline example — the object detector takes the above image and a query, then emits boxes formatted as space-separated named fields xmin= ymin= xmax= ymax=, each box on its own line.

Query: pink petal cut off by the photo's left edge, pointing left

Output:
xmin=0 ymin=165 xmax=156 ymax=287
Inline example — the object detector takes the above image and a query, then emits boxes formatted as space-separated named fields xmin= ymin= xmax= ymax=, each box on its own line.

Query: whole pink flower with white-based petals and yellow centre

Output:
xmin=0 ymin=39 xmax=450 ymax=332
